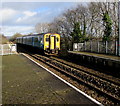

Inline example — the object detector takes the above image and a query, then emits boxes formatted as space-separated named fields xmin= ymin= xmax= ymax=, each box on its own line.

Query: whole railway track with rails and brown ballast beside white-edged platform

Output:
xmin=25 ymin=54 xmax=120 ymax=104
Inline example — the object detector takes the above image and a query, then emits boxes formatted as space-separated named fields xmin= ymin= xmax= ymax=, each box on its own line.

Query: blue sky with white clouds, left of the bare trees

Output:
xmin=0 ymin=2 xmax=80 ymax=36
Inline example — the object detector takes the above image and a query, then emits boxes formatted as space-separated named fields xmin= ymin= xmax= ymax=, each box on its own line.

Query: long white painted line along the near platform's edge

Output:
xmin=21 ymin=53 xmax=103 ymax=106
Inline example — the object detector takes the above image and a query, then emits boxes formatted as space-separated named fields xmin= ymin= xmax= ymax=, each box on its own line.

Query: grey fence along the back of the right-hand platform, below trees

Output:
xmin=73 ymin=41 xmax=118 ymax=55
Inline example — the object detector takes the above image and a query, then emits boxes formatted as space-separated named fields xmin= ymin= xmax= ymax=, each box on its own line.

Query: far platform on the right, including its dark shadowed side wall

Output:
xmin=68 ymin=51 xmax=120 ymax=77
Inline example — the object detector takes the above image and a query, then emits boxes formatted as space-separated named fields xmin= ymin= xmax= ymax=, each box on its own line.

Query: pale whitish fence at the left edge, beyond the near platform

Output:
xmin=0 ymin=44 xmax=17 ymax=55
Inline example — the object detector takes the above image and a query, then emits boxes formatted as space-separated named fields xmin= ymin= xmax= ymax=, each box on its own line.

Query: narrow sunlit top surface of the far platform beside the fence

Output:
xmin=69 ymin=51 xmax=120 ymax=62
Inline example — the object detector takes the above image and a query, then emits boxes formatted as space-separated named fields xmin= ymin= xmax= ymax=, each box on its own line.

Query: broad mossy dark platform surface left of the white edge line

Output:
xmin=2 ymin=54 xmax=96 ymax=106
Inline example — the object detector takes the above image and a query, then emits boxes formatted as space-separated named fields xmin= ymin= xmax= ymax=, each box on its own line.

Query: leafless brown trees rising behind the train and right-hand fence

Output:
xmin=35 ymin=2 xmax=118 ymax=48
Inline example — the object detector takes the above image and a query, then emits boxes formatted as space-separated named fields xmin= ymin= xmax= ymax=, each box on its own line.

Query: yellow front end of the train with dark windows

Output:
xmin=44 ymin=33 xmax=60 ymax=54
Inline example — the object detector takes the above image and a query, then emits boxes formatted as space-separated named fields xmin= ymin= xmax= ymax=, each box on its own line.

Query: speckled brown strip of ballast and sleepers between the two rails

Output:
xmin=30 ymin=54 xmax=120 ymax=102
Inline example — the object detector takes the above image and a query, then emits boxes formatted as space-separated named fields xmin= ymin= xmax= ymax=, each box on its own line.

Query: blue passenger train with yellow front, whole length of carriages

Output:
xmin=16 ymin=33 xmax=60 ymax=54
